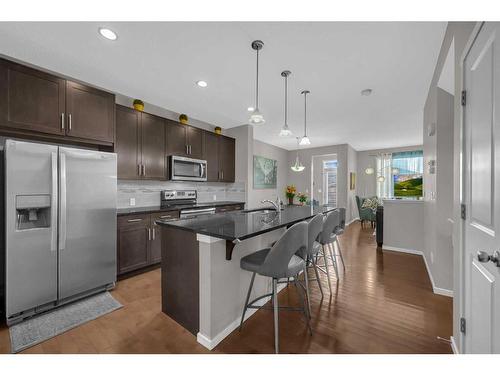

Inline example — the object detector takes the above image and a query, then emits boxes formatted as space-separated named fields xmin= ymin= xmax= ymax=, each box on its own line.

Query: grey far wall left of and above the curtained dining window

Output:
xmin=356 ymin=145 xmax=423 ymax=197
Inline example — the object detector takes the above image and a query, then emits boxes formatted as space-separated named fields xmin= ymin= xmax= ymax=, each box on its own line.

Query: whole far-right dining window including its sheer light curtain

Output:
xmin=376 ymin=150 xmax=424 ymax=198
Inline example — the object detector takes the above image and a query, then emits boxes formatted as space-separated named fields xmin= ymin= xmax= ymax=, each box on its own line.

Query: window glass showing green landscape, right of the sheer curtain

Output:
xmin=392 ymin=151 xmax=424 ymax=198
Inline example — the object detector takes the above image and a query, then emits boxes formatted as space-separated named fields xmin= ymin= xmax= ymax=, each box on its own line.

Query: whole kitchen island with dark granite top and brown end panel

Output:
xmin=156 ymin=206 xmax=334 ymax=349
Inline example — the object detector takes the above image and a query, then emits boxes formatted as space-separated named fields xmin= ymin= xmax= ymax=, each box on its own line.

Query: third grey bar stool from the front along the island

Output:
xmin=316 ymin=210 xmax=339 ymax=294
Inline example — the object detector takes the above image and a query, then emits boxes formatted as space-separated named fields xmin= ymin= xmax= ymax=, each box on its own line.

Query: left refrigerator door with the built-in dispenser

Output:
xmin=5 ymin=140 xmax=58 ymax=318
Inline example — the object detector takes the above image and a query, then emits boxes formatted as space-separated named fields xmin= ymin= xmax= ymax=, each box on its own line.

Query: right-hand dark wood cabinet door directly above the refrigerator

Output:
xmin=66 ymin=81 xmax=115 ymax=143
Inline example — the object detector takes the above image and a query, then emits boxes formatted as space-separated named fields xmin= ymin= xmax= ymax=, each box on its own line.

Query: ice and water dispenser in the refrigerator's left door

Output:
xmin=16 ymin=194 xmax=50 ymax=230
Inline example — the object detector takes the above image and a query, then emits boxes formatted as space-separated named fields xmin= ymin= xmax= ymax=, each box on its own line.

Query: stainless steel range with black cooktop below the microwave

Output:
xmin=161 ymin=190 xmax=215 ymax=219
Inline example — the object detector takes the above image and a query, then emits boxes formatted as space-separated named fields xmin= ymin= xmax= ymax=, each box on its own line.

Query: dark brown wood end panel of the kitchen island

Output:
xmin=161 ymin=226 xmax=200 ymax=335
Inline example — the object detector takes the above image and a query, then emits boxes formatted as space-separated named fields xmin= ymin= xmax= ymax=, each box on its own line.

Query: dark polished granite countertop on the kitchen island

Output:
xmin=156 ymin=206 xmax=335 ymax=241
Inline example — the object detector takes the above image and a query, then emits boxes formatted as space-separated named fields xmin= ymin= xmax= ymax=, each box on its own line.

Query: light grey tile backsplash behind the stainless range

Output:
xmin=117 ymin=180 xmax=246 ymax=208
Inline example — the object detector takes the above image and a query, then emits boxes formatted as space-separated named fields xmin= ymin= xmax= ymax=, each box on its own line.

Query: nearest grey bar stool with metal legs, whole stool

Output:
xmin=240 ymin=221 xmax=312 ymax=353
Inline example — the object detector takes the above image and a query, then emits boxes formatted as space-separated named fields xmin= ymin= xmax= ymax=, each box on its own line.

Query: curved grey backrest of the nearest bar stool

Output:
xmin=258 ymin=221 xmax=307 ymax=278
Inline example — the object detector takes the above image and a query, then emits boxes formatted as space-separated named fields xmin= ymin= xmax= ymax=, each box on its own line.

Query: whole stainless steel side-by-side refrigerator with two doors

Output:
xmin=4 ymin=140 xmax=116 ymax=324
